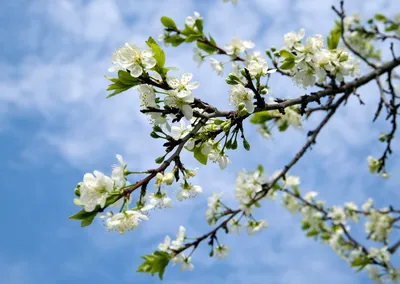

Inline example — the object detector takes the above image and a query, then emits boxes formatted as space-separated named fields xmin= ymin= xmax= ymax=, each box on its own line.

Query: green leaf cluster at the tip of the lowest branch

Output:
xmin=137 ymin=251 xmax=171 ymax=280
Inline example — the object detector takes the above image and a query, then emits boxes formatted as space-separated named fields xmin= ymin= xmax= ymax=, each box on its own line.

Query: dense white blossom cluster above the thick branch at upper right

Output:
xmin=279 ymin=29 xmax=359 ymax=88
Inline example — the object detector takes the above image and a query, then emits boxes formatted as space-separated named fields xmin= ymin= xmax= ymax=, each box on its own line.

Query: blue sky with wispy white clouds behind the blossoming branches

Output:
xmin=0 ymin=0 xmax=400 ymax=284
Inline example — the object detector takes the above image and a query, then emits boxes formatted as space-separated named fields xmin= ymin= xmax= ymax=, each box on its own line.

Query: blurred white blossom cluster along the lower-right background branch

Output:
xmin=282 ymin=186 xmax=399 ymax=283
